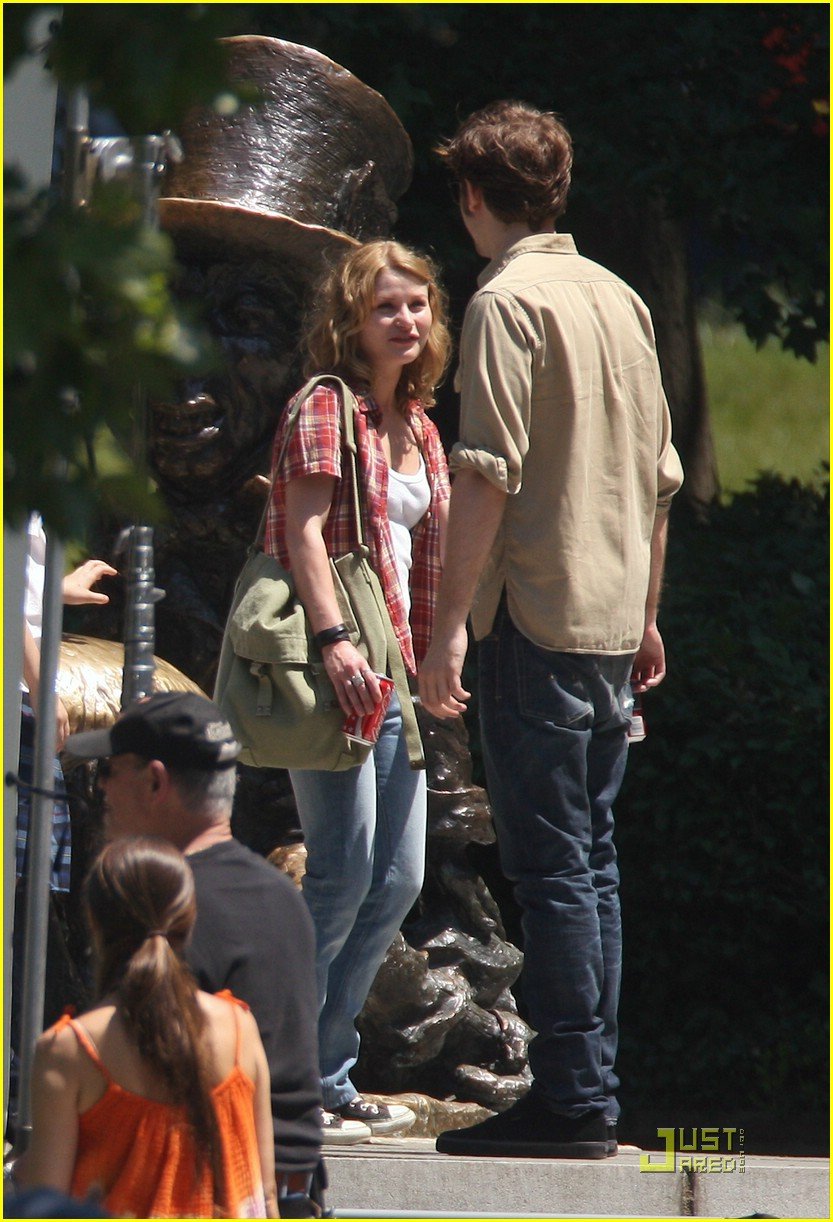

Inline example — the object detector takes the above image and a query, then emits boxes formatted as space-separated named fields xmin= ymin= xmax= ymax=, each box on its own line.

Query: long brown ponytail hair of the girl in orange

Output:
xmin=83 ymin=837 xmax=222 ymax=1199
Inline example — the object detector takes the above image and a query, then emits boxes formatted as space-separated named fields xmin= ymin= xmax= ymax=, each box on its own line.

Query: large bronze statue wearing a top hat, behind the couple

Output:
xmin=69 ymin=35 xmax=531 ymax=1127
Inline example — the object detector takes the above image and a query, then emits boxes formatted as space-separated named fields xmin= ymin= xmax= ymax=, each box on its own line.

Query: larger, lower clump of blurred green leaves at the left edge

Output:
xmin=4 ymin=174 xmax=210 ymax=538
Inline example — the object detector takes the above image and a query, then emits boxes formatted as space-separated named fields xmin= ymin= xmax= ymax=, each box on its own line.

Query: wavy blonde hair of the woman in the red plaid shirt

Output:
xmin=304 ymin=241 xmax=451 ymax=411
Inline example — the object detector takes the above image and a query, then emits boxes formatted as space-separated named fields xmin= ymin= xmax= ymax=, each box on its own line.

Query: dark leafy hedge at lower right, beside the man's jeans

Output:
xmin=617 ymin=478 xmax=829 ymax=1123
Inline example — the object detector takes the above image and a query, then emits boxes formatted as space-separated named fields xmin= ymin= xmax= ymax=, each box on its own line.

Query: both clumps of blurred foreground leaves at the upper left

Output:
xmin=4 ymin=5 xmax=246 ymax=538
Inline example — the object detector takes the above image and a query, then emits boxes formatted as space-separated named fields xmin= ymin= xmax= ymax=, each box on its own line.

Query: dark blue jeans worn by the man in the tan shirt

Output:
xmin=479 ymin=601 xmax=633 ymax=1121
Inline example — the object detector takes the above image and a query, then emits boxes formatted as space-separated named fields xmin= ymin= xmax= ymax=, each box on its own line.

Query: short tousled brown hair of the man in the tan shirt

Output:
xmin=436 ymin=101 xmax=573 ymax=230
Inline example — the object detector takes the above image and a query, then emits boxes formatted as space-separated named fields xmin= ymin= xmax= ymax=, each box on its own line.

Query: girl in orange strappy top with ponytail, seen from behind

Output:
xmin=15 ymin=838 xmax=278 ymax=1218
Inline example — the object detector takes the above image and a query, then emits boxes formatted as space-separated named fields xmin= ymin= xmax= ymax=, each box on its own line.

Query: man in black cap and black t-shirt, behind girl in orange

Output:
xmin=66 ymin=692 xmax=346 ymax=1216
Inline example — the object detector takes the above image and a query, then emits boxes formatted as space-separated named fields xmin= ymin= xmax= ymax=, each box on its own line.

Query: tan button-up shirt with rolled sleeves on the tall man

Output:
xmin=451 ymin=233 xmax=683 ymax=654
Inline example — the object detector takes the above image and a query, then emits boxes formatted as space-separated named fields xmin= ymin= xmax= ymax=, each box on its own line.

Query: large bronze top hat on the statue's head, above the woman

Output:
xmin=159 ymin=34 xmax=413 ymax=266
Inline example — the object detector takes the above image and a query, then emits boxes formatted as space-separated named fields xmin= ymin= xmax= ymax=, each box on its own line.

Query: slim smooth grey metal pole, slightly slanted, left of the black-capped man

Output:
xmin=15 ymin=534 xmax=64 ymax=1156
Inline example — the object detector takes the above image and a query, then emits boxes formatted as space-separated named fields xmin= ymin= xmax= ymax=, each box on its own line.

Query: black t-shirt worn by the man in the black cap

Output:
xmin=186 ymin=840 xmax=321 ymax=1172
